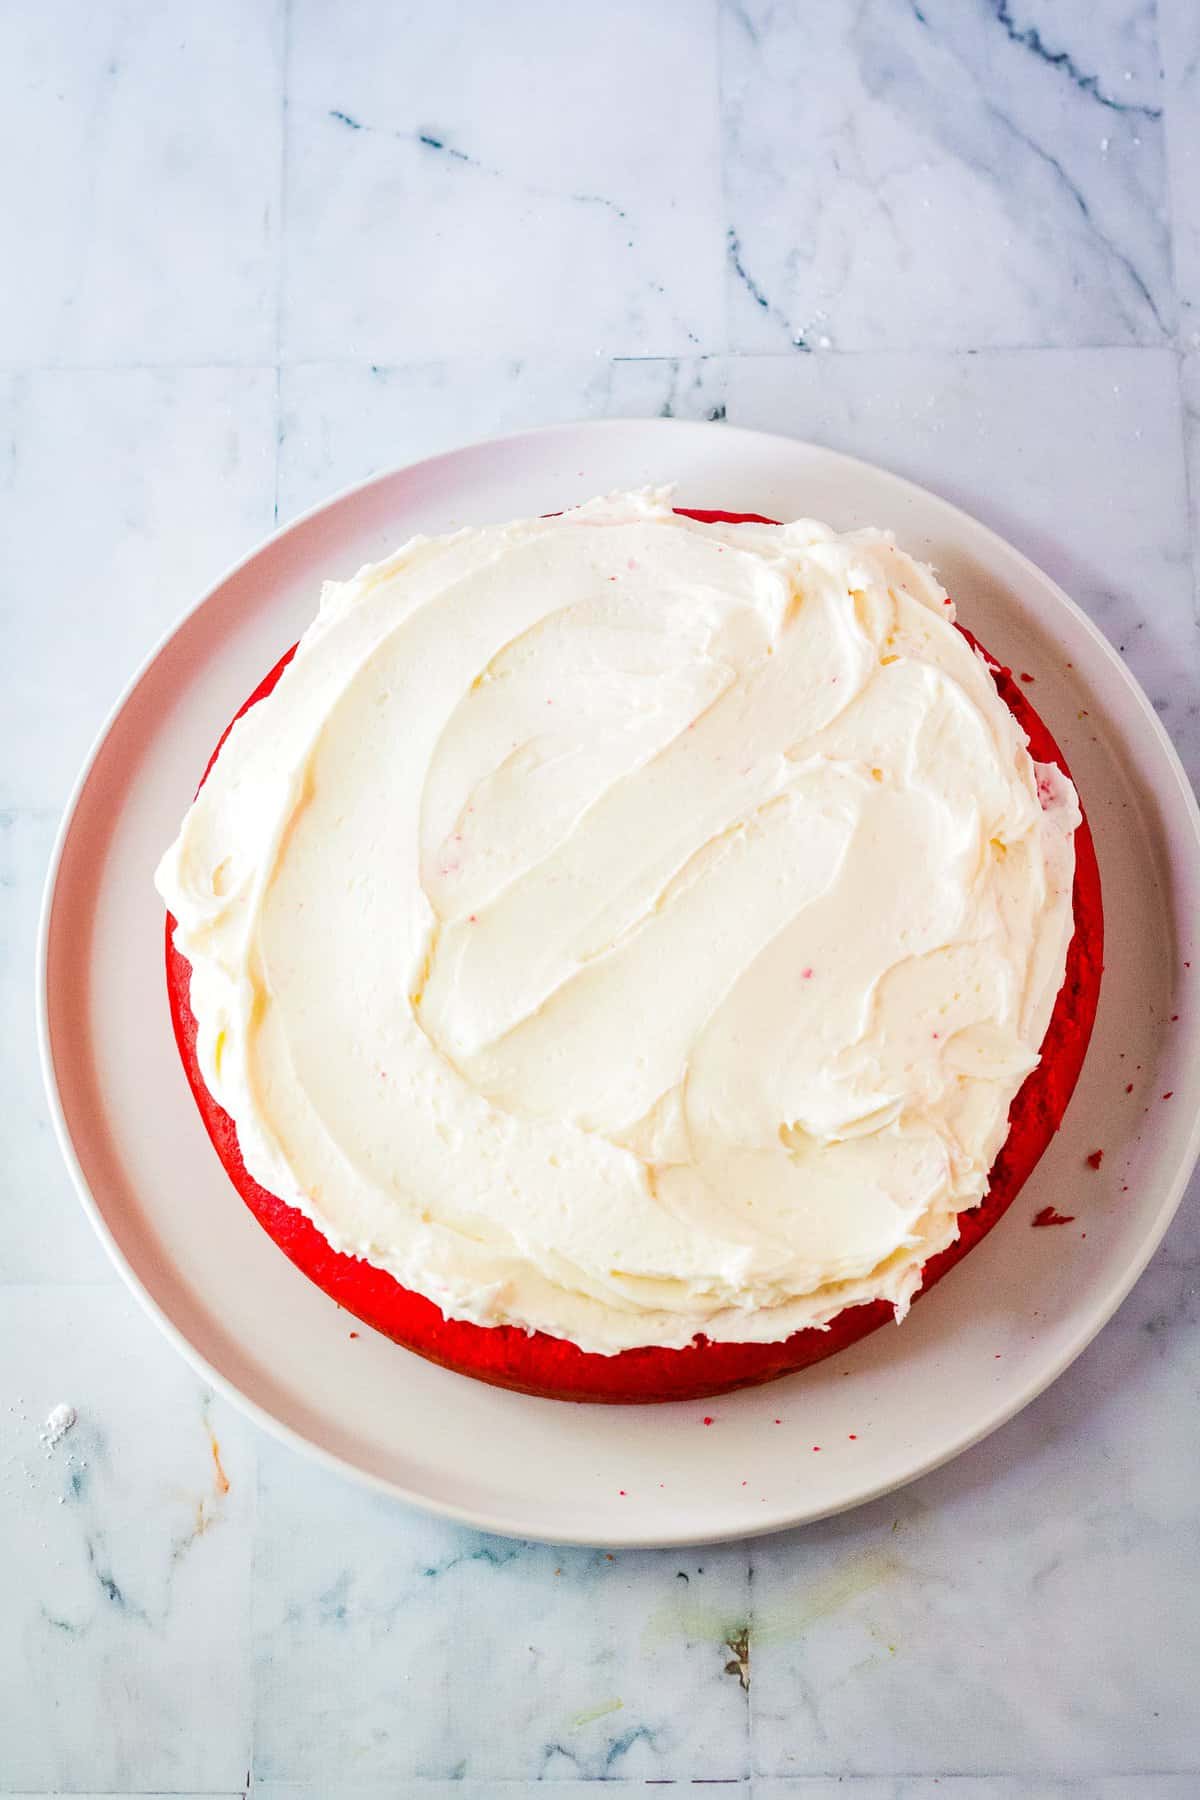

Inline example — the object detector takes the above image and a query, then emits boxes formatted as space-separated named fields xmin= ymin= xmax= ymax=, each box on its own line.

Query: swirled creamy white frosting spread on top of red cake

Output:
xmin=157 ymin=491 xmax=1079 ymax=1352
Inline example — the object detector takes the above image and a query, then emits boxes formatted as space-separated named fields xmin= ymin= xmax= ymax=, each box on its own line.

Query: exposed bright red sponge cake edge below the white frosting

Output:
xmin=167 ymin=509 xmax=1103 ymax=1404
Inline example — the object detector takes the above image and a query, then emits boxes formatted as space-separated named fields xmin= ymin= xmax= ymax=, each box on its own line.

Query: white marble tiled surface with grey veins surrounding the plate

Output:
xmin=0 ymin=0 xmax=1200 ymax=1800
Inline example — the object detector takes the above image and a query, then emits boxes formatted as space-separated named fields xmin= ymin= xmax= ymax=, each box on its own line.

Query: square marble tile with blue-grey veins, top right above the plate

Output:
xmin=721 ymin=0 xmax=1175 ymax=351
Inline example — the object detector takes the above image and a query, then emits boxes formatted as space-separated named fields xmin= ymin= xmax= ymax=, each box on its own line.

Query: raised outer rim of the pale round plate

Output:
xmin=34 ymin=416 xmax=1200 ymax=1550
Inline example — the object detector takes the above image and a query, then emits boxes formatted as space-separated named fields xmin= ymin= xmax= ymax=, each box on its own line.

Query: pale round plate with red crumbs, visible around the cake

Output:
xmin=38 ymin=421 xmax=1200 ymax=1544
